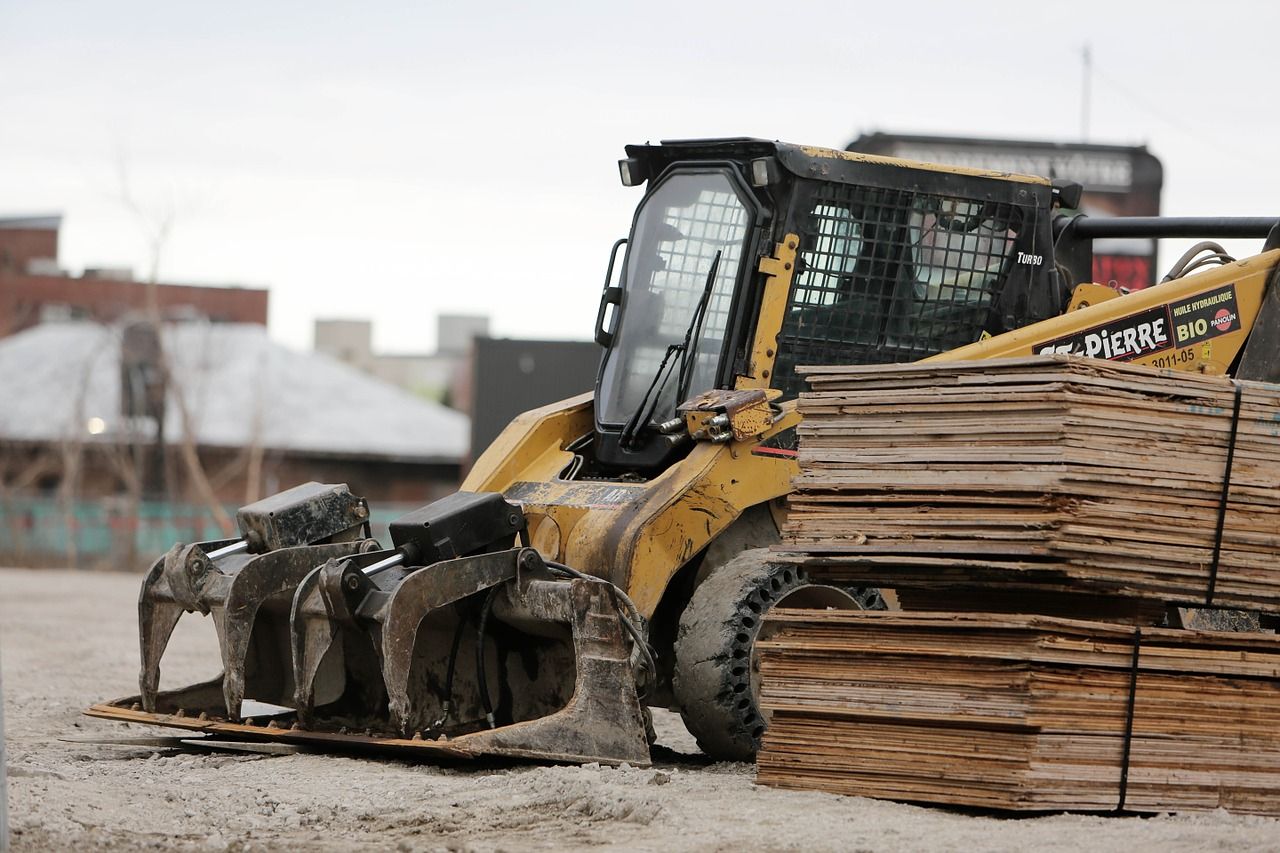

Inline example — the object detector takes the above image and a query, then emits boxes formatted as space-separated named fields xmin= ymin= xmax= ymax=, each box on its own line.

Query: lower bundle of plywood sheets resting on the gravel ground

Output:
xmin=758 ymin=610 xmax=1280 ymax=815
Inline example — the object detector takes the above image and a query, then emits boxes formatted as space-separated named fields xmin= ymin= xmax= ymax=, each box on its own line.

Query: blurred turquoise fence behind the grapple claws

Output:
xmin=0 ymin=497 xmax=415 ymax=570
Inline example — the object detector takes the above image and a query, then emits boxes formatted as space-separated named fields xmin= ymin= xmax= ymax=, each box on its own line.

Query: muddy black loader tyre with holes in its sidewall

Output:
xmin=672 ymin=548 xmax=883 ymax=761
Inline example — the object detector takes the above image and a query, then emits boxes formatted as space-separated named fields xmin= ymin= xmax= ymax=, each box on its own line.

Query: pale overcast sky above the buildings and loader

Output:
xmin=0 ymin=0 xmax=1280 ymax=352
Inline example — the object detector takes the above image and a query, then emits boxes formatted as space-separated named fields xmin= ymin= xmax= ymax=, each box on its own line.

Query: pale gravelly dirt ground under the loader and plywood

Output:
xmin=0 ymin=560 xmax=1280 ymax=853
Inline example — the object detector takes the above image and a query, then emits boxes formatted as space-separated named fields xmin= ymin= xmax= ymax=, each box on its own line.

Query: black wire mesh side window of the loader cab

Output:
xmin=774 ymin=183 xmax=1021 ymax=396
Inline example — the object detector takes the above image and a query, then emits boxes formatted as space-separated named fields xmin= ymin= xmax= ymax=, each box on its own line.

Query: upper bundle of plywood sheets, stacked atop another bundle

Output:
xmin=780 ymin=356 xmax=1280 ymax=611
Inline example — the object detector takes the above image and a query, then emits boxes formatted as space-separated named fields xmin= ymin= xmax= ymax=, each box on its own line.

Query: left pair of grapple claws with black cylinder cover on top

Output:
xmin=138 ymin=483 xmax=376 ymax=717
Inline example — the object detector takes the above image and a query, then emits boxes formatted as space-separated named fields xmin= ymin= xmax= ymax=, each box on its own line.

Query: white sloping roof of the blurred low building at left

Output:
xmin=0 ymin=323 xmax=470 ymax=462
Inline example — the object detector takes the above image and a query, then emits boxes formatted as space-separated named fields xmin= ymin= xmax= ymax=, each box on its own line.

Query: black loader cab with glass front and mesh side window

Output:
xmin=591 ymin=140 xmax=1066 ymax=479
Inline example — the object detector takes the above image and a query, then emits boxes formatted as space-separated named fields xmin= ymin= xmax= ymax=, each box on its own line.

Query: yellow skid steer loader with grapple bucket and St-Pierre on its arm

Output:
xmin=90 ymin=140 xmax=1280 ymax=765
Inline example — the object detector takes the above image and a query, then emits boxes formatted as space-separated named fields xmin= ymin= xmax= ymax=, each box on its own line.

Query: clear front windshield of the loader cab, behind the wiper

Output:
xmin=598 ymin=172 xmax=751 ymax=424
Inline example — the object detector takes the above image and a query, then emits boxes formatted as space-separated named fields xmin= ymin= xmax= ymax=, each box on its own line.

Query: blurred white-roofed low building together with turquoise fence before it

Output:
xmin=0 ymin=321 xmax=468 ymax=567
